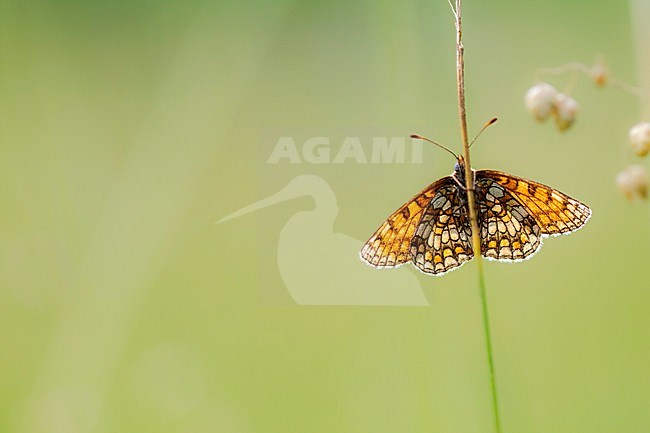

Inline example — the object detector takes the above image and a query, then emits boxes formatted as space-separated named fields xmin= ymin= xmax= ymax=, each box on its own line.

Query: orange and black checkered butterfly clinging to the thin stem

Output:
xmin=360 ymin=152 xmax=591 ymax=275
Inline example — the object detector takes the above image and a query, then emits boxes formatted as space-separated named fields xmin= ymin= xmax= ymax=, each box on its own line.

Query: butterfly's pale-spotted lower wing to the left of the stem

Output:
xmin=410 ymin=179 xmax=474 ymax=275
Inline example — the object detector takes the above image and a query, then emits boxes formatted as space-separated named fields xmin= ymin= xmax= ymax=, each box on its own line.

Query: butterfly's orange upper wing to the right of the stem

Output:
xmin=476 ymin=170 xmax=591 ymax=235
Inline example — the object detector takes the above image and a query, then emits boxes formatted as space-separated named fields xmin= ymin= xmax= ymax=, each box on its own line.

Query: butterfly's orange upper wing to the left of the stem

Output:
xmin=360 ymin=176 xmax=454 ymax=268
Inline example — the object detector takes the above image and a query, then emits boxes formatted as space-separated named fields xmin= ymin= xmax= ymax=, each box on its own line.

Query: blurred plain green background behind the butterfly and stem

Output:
xmin=0 ymin=0 xmax=650 ymax=433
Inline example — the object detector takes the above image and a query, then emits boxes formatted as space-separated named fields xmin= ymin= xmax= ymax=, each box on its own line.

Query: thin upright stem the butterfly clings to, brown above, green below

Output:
xmin=450 ymin=0 xmax=501 ymax=433
